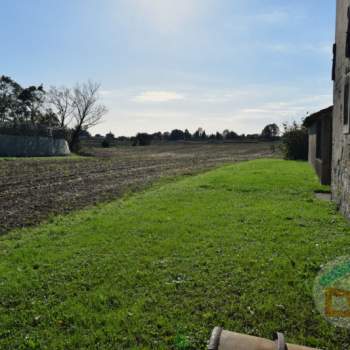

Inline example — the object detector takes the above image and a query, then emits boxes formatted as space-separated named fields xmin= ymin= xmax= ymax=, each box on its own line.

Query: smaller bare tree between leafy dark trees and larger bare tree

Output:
xmin=47 ymin=86 xmax=72 ymax=128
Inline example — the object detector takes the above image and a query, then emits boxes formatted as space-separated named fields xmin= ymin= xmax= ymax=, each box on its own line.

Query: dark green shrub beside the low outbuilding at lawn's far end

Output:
xmin=282 ymin=122 xmax=309 ymax=160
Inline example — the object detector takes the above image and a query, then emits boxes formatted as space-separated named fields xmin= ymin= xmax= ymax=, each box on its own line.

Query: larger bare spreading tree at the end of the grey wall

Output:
xmin=70 ymin=81 xmax=107 ymax=151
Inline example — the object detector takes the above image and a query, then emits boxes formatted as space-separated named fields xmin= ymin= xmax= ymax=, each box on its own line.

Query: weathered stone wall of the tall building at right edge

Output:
xmin=332 ymin=0 xmax=350 ymax=217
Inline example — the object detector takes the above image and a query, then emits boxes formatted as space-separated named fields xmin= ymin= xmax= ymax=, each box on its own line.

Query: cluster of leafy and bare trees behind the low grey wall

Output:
xmin=0 ymin=76 xmax=107 ymax=151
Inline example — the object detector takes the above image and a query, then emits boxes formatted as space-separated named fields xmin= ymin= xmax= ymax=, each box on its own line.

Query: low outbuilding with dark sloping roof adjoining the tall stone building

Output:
xmin=304 ymin=106 xmax=333 ymax=185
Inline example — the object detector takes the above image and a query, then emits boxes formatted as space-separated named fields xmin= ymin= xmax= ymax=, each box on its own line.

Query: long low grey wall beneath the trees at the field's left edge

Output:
xmin=0 ymin=135 xmax=70 ymax=157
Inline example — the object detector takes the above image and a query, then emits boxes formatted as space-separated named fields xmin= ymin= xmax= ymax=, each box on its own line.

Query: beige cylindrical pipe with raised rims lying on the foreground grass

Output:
xmin=208 ymin=327 xmax=317 ymax=350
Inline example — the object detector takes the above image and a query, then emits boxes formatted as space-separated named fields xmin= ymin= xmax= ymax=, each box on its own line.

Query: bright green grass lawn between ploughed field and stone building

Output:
xmin=0 ymin=160 xmax=350 ymax=350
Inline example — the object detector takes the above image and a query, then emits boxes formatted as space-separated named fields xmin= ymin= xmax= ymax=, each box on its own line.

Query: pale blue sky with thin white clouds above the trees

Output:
xmin=0 ymin=0 xmax=335 ymax=135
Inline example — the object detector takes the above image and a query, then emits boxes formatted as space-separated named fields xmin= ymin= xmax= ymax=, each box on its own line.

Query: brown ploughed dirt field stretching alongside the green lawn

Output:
xmin=0 ymin=143 xmax=277 ymax=234
